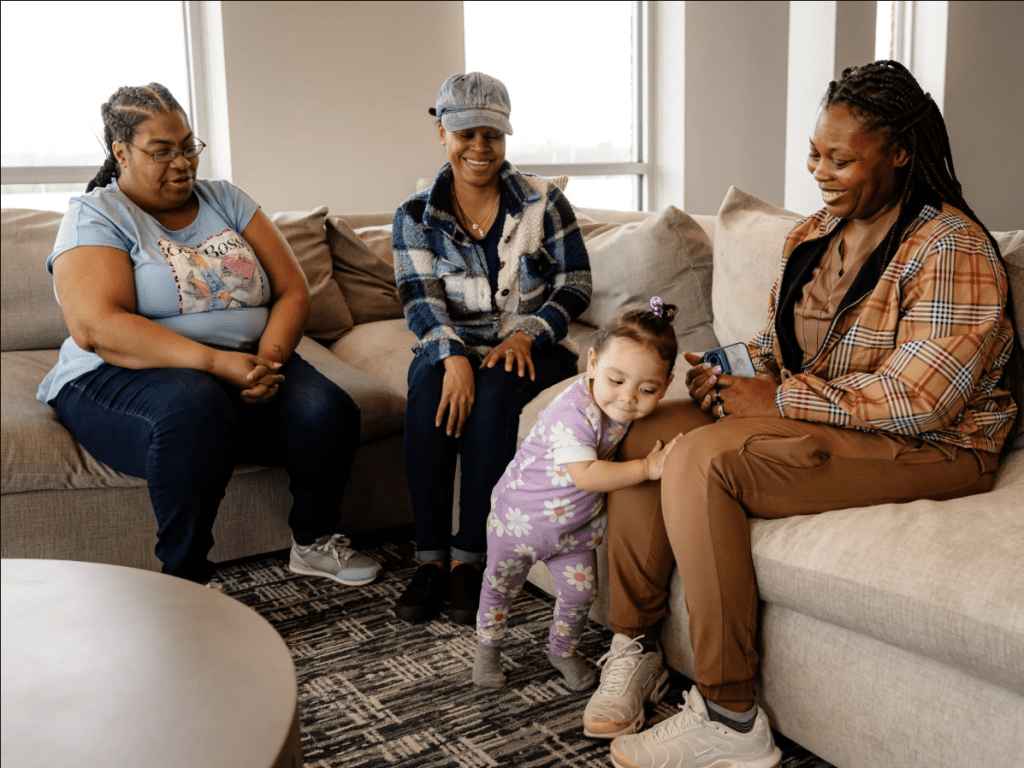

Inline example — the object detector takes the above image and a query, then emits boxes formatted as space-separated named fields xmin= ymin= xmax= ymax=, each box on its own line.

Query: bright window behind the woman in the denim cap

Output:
xmin=464 ymin=0 xmax=647 ymax=210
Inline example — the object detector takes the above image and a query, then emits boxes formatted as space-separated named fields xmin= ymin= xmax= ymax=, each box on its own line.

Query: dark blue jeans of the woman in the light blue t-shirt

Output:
xmin=50 ymin=354 xmax=359 ymax=583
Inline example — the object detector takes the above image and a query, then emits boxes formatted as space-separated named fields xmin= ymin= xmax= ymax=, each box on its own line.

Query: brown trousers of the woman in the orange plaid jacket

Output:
xmin=608 ymin=400 xmax=997 ymax=711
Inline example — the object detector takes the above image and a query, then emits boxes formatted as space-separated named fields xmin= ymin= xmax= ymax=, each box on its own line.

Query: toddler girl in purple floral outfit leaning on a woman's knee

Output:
xmin=473 ymin=297 xmax=678 ymax=690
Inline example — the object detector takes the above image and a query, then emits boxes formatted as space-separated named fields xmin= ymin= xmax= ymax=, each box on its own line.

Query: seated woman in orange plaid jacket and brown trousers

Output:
xmin=584 ymin=61 xmax=1021 ymax=768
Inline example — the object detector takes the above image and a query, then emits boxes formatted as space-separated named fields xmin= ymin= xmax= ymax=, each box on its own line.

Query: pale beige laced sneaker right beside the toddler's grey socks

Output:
xmin=583 ymin=635 xmax=669 ymax=738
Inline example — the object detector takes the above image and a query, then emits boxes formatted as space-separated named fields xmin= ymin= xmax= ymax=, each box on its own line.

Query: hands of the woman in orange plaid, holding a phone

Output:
xmin=683 ymin=352 xmax=778 ymax=419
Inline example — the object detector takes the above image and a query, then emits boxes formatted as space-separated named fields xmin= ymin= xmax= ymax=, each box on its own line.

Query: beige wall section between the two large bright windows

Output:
xmin=221 ymin=2 xmax=465 ymax=213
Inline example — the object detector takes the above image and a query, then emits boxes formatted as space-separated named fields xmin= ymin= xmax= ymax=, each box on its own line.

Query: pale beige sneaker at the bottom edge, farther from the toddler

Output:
xmin=611 ymin=686 xmax=782 ymax=768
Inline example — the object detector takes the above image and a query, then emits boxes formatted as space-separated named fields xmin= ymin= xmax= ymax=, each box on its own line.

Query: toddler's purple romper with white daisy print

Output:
xmin=476 ymin=376 xmax=629 ymax=656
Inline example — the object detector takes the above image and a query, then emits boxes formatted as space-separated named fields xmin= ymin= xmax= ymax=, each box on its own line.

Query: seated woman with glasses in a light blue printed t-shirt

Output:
xmin=38 ymin=83 xmax=380 ymax=585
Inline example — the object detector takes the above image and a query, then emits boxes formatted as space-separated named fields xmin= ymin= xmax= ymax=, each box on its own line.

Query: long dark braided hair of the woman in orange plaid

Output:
xmin=821 ymin=60 xmax=1024 ymax=450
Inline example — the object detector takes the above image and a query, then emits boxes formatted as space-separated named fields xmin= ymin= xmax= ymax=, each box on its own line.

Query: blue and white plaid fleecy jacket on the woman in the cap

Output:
xmin=392 ymin=161 xmax=591 ymax=362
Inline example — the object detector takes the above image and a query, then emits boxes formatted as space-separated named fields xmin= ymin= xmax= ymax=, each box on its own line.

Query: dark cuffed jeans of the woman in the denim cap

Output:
xmin=406 ymin=345 xmax=577 ymax=563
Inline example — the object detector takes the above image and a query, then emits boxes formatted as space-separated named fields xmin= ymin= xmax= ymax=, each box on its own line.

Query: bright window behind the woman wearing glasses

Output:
xmin=0 ymin=0 xmax=196 ymax=210
